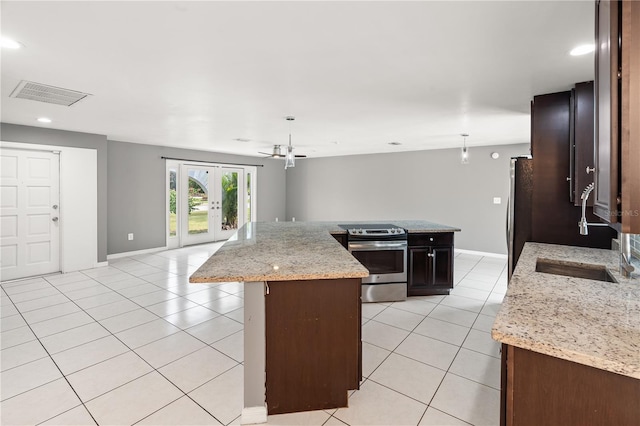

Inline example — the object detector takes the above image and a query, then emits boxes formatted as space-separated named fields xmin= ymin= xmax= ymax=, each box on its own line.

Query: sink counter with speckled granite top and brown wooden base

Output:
xmin=491 ymin=243 xmax=640 ymax=425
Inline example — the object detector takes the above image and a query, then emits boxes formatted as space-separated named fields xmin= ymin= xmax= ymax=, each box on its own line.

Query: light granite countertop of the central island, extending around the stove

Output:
xmin=189 ymin=220 xmax=460 ymax=283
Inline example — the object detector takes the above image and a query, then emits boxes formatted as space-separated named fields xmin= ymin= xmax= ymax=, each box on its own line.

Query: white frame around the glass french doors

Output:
xmin=165 ymin=159 xmax=258 ymax=249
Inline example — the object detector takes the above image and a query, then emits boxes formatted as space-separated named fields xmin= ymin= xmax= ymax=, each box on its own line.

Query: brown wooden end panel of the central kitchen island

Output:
xmin=265 ymin=278 xmax=362 ymax=414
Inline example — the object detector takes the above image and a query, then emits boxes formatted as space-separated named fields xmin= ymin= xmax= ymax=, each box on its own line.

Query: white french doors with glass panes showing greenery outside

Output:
xmin=167 ymin=163 xmax=255 ymax=248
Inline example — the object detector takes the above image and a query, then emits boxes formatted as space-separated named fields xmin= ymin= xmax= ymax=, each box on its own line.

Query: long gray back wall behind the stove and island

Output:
xmin=286 ymin=144 xmax=529 ymax=254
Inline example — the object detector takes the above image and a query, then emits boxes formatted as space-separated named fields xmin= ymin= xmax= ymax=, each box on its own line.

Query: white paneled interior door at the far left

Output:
xmin=0 ymin=149 xmax=60 ymax=281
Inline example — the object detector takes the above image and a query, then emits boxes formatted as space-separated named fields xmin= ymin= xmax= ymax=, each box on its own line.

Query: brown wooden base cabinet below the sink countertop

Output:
xmin=500 ymin=345 xmax=640 ymax=426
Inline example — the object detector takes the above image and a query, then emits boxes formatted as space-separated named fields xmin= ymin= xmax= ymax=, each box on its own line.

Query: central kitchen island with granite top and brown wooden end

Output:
xmin=189 ymin=221 xmax=459 ymax=423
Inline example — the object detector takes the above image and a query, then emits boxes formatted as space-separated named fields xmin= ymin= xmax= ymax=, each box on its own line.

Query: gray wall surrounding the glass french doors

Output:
xmin=107 ymin=140 xmax=286 ymax=254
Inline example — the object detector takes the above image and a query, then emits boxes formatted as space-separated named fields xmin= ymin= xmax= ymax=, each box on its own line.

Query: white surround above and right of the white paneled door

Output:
xmin=0 ymin=141 xmax=101 ymax=273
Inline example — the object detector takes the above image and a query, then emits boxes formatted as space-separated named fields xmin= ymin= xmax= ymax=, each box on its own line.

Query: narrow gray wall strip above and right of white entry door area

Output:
xmin=0 ymin=123 xmax=108 ymax=262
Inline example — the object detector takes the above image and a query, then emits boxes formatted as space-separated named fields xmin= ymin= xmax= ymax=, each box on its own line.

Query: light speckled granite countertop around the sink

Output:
xmin=491 ymin=243 xmax=640 ymax=379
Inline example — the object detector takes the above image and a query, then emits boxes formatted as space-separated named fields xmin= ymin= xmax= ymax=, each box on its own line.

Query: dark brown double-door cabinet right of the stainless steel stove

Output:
xmin=407 ymin=232 xmax=453 ymax=296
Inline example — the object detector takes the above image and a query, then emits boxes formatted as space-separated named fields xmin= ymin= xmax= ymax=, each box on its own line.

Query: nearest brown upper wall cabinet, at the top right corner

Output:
xmin=593 ymin=0 xmax=640 ymax=234
